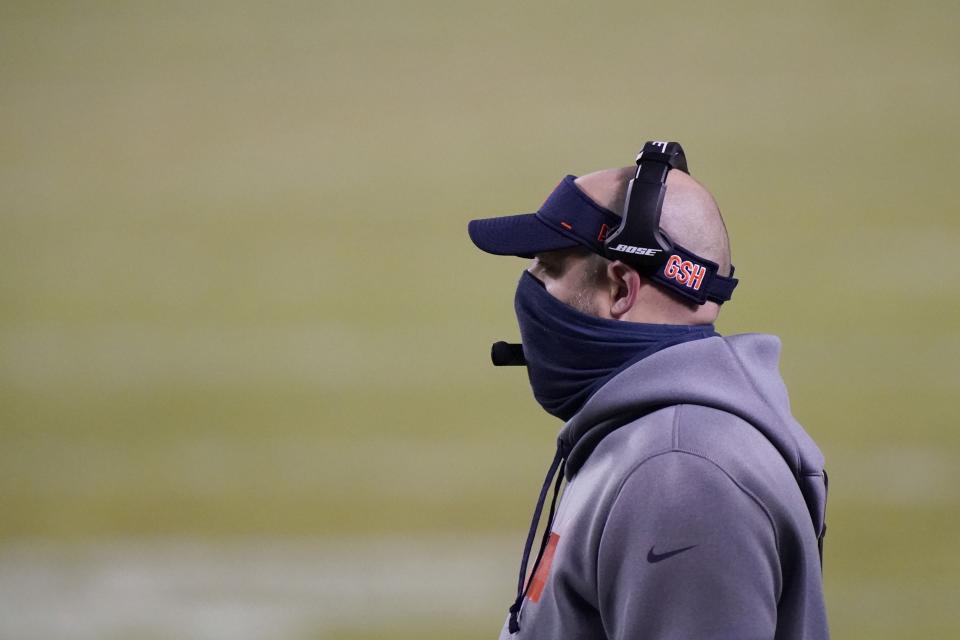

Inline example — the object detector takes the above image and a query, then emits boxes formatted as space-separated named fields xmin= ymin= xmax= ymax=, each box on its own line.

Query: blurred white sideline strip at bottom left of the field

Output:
xmin=0 ymin=535 xmax=522 ymax=640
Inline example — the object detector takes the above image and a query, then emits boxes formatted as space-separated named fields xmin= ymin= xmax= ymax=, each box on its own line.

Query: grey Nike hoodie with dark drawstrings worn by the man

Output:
xmin=500 ymin=334 xmax=829 ymax=640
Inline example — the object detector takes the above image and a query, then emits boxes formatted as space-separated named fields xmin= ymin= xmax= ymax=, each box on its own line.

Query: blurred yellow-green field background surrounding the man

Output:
xmin=0 ymin=0 xmax=960 ymax=640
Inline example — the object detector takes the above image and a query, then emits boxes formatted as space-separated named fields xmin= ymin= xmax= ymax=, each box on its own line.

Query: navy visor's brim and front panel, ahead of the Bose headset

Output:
xmin=467 ymin=176 xmax=620 ymax=258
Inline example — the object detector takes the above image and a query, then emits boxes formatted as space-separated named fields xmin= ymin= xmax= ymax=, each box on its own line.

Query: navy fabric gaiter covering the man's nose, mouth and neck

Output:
xmin=513 ymin=271 xmax=719 ymax=421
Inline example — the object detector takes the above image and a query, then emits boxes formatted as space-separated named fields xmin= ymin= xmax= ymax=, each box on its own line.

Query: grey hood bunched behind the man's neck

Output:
xmin=558 ymin=334 xmax=826 ymax=530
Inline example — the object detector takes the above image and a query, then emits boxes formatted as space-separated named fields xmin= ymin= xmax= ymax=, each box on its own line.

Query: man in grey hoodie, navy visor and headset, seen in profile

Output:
xmin=469 ymin=143 xmax=829 ymax=640
